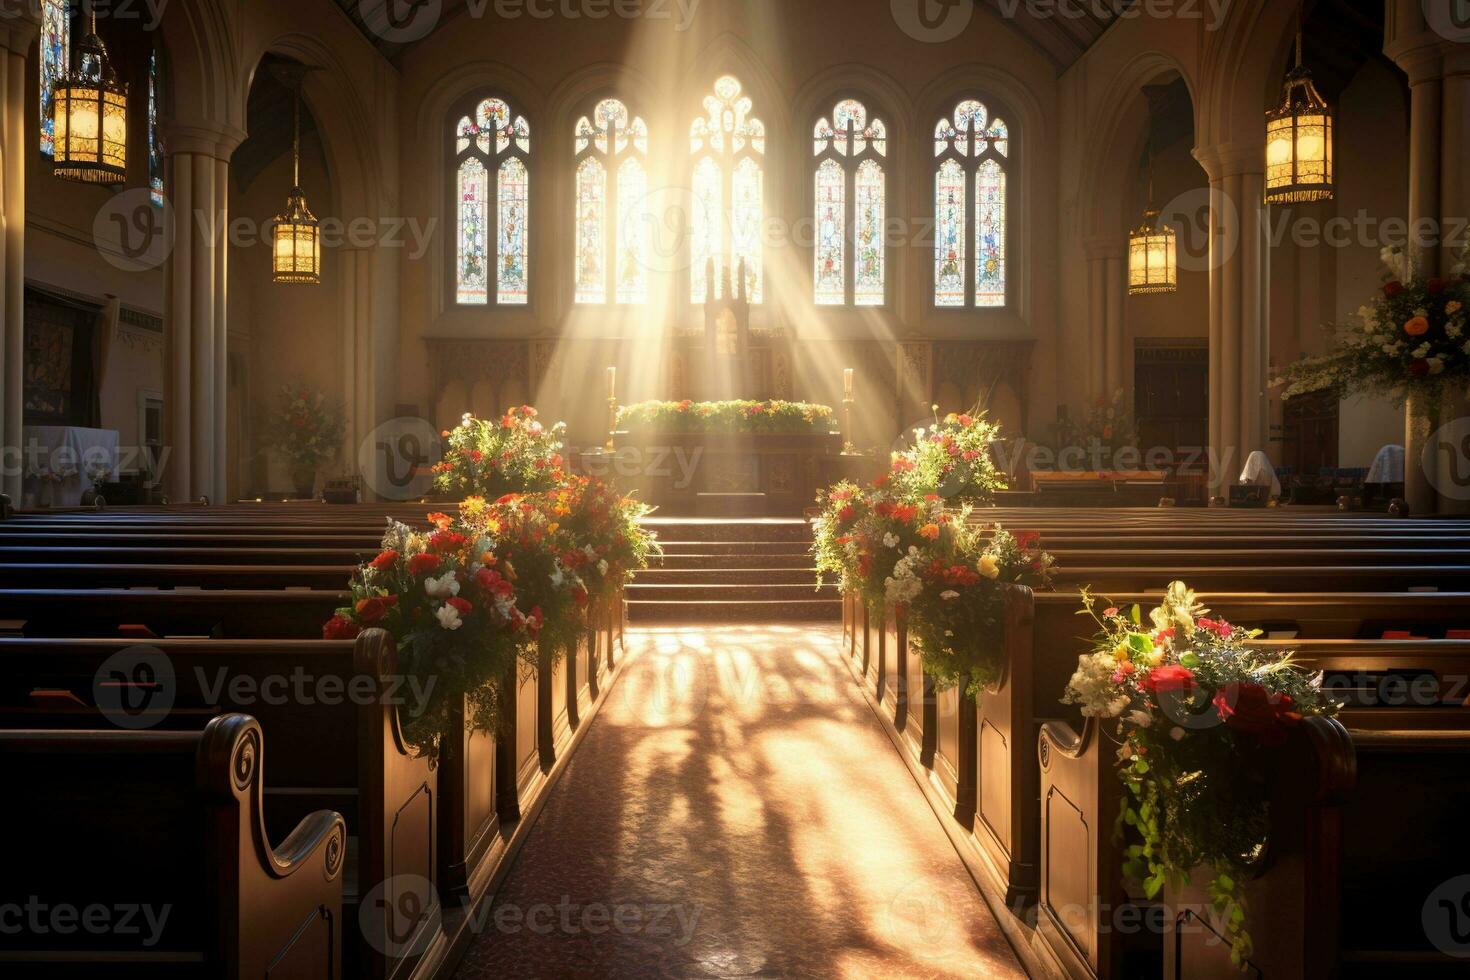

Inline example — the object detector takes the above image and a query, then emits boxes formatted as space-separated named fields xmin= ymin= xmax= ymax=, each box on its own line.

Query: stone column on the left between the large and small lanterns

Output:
xmin=165 ymin=125 xmax=244 ymax=504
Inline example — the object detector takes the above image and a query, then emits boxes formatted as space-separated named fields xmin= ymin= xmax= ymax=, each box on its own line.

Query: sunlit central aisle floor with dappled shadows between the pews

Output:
xmin=459 ymin=624 xmax=1025 ymax=980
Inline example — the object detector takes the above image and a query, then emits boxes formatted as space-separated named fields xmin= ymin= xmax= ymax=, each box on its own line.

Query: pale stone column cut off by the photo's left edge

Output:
xmin=0 ymin=11 xmax=38 ymax=507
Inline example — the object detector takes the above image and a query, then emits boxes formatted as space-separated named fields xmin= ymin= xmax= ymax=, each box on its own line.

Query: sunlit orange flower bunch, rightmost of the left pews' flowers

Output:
xmin=553 ymin=476 xmax=663 ymax=599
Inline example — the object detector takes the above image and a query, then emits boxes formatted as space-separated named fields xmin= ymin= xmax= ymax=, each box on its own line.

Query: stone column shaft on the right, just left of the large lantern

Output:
xmin=1195 ymin=141 xmax=1270 ymax=494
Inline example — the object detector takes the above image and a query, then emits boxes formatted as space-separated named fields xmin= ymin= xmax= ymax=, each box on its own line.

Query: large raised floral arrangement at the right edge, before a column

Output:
xmin=1273 ymin=245 xmax=1470 ymax=404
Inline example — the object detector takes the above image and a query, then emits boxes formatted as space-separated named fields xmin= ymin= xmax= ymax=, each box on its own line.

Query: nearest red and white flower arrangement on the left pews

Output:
xmin=322 ymin=498 xmax=552 ymax=758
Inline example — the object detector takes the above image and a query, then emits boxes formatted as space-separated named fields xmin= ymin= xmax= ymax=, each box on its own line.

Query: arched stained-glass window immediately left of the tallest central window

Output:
xmin=573 ymin=98 xmax=653 ymax=304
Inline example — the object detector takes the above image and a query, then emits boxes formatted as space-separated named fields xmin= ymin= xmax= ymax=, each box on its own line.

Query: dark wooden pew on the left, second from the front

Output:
xmin=0 ymin=630 xmax=444 ymax=977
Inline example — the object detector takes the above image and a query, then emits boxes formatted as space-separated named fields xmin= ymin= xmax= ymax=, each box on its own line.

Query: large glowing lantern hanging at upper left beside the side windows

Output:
xmin=51 ymin=9 xmax=128 ymax=184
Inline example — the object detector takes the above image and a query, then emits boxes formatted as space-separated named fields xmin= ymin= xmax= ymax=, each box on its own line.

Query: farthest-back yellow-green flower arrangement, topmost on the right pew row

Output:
xmin=892 ymin=406 xmax=1005 ymax=502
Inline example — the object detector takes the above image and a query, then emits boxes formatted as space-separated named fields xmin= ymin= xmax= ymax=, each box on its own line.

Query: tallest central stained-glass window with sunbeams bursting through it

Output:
xmin=689 ymin=75 xmax=766 ymax=303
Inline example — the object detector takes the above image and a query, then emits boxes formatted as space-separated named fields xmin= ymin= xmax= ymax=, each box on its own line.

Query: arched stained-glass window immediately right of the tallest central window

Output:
xmin=811 ymin=98 xmax=888 ymax=306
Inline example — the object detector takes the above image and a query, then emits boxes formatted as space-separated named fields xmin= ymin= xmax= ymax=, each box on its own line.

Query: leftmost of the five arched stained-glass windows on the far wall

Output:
xmin=453 ymin=97 xmax=531 ymax=306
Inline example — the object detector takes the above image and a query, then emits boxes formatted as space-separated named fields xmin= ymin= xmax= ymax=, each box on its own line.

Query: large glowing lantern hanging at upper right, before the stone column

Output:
xmin=1266 ymin=25 xmax=1333 ymax=204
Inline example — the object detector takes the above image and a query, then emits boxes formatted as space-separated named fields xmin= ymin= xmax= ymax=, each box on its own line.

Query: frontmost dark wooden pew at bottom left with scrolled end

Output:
xmin=0 ymin=714 xmax=347 ymax=979
